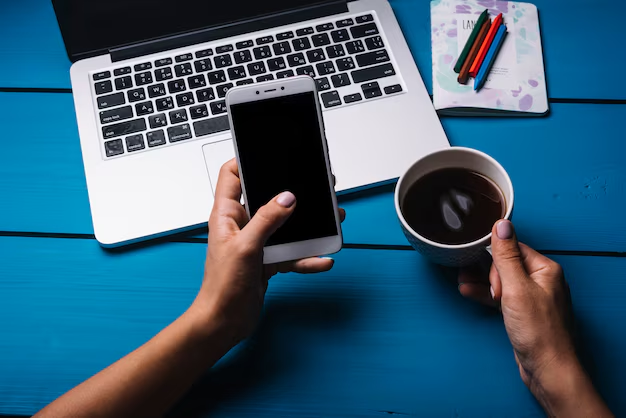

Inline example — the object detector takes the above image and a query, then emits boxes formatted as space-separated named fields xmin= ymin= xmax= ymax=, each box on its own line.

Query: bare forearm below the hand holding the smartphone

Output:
xmin=37 ymin=307 xmax=232 ymax=417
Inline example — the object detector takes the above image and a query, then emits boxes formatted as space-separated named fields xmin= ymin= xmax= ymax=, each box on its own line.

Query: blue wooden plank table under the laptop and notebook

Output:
xmin=0 ymin=0 xmax=626 ymax=417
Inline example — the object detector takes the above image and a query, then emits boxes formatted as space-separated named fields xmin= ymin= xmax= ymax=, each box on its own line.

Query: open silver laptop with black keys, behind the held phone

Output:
xmin=52 ymin=0 xmax=449 ymax=247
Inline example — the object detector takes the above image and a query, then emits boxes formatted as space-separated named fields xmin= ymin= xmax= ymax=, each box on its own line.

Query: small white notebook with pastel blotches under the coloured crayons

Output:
xmin=431 ymin=0 xmax=548 ymax=116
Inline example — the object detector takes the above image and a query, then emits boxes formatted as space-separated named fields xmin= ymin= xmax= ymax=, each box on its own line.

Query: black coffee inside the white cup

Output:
xmin=401 ymin=168 xmax=506 ymax=244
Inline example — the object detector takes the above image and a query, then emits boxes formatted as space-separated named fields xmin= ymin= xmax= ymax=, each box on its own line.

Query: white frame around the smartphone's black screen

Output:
xmin=226 ymin=76 xmax=343 ymax=264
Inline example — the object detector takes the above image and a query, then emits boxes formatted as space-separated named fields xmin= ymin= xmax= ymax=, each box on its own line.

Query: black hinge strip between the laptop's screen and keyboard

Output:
xmin=109 ymin=0 xmax=348 ymax=62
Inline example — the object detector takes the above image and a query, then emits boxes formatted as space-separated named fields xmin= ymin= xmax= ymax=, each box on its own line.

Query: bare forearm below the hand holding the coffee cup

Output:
xmin=530 ymin=360 xmax=613 ymax=418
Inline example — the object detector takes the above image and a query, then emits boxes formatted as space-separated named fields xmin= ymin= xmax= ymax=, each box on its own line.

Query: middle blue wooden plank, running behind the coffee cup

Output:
xmin=0 ymin=93 xmax=626 ymax=251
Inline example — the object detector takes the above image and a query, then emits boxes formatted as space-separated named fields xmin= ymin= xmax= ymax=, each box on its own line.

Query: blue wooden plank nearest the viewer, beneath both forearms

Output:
xmin=0 ymin=237 xmax=626 ymax=417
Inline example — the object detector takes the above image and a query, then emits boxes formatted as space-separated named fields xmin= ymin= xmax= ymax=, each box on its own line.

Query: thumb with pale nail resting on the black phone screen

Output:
xmin=243 ymin=192 xmax=296 ymax=246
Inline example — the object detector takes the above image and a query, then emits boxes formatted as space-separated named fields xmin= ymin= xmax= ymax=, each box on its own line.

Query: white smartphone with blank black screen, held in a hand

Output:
xmin=226 ymin=76 xmax=343 ymax=264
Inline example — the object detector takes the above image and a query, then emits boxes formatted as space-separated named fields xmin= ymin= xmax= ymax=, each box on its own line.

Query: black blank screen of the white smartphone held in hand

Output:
xmin=230 ymin=92 xmax=338 ymax=246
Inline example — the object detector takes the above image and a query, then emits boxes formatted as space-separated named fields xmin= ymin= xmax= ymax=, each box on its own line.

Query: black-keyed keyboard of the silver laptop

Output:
xmin=92 ymin=13 xmax=404 ymax=158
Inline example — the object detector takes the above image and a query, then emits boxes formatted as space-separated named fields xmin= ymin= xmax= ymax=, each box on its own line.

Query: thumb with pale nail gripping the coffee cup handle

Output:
xmin=491 ymin=220 xmax=528 ymax=288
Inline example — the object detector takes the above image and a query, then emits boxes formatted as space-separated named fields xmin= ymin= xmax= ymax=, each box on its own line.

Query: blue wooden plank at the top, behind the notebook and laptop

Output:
xmin=0 ymin=0 xmax=626 ymax=99
